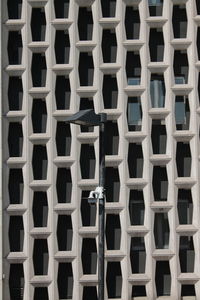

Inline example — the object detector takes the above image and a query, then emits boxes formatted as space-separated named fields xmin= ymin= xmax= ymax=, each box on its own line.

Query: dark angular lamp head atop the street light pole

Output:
xmin=65 ymin=109 xmax=106 ymax=127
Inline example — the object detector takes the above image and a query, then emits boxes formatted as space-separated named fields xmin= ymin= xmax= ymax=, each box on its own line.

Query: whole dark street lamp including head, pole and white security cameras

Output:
xmin=66 ymin=109 xmax=107 ymax=300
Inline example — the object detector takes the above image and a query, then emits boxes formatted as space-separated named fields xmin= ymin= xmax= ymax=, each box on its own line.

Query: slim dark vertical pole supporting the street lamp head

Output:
xmin=98 ymin=119 xmax=105 ymax=300
